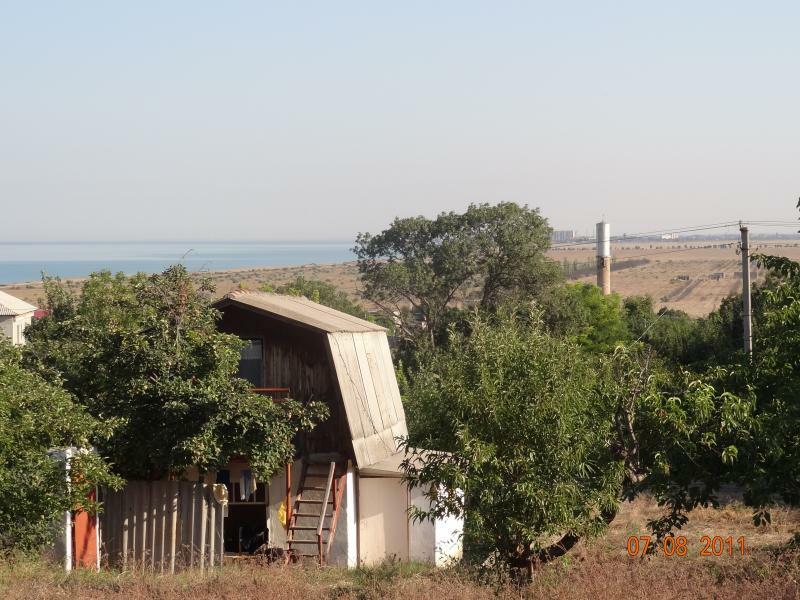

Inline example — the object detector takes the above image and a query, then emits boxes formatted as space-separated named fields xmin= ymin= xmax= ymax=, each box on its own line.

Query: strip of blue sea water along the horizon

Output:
xmin=0 ymin=242 xmax=355 ymax=284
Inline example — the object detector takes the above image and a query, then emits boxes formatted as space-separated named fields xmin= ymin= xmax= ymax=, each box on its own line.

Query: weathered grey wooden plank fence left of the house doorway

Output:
xmin=100 ymin=481 xmax=225 ymax=573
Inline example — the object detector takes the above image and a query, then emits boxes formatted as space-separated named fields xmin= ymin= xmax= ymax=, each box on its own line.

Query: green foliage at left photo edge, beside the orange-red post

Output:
xmin=0 ymin=337 xmax=119 ymax=553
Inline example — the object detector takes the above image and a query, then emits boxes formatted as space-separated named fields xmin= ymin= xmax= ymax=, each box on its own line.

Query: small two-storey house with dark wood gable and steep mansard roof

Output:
xmin=205 ymin=291 xmax=462 ymax=567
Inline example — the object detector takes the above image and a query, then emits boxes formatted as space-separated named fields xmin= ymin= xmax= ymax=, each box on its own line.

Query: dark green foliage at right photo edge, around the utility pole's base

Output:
xmin=637 ymin=244 xmax=800 ymax=533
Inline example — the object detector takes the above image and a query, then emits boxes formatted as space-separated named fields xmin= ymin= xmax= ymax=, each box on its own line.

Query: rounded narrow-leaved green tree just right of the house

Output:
xmin=405 ymin=311 xmax=623 ymax=565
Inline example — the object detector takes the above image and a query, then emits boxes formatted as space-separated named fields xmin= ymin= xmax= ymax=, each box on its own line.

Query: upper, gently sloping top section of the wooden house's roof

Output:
xmin=216 ymin=290 xmax=386 ymax=333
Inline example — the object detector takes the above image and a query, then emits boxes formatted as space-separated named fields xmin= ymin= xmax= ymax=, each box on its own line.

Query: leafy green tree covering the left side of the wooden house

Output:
xmin=25 ymin=266 xmax=324 ymax=479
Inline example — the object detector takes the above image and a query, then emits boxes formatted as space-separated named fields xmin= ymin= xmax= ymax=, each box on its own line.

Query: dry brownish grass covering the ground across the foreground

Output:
xmin=0 ymin=500 xmax=800 ymax=600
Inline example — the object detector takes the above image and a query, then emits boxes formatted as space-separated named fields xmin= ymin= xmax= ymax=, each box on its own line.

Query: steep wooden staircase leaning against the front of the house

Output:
xmin=287 ymin=459 xmax=347 ymax=565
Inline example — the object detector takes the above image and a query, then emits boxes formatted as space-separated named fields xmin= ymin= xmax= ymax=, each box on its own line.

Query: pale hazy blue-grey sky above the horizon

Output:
xmin=0 ymin=0 xmax=800 ymax=241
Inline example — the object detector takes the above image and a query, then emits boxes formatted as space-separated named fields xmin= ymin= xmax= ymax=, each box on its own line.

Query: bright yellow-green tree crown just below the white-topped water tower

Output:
xmin=543 ymin=283 xmax=629 ymax=352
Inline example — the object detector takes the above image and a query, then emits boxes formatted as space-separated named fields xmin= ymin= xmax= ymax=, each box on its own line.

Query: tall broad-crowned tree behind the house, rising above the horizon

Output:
xmin=353 ymin=202 xmax=559 ymax=345
